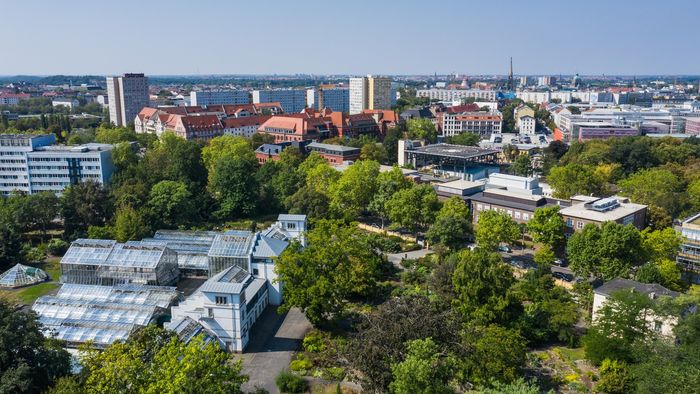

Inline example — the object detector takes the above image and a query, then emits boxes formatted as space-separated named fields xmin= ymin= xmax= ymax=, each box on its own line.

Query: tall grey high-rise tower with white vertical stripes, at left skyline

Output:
xmin=107 ymin=74 xmax=149 ymax=126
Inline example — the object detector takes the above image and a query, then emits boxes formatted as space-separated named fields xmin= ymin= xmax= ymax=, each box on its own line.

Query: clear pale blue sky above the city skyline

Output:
xmin=5 ymin=0 xmax=700 ymax=75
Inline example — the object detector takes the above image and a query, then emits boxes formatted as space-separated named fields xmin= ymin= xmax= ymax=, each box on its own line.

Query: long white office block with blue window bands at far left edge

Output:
xmin=0 ymin=134 xmax=114 ymax=196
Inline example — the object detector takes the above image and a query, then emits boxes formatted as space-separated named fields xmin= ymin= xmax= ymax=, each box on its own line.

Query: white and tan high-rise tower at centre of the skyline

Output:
xmin=350 ymin=75 xmax=392 ymax=115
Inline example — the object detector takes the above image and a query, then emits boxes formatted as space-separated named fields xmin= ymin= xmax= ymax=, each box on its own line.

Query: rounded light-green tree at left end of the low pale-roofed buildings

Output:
xmin=386 ymin=185 xmax=438 ymax=232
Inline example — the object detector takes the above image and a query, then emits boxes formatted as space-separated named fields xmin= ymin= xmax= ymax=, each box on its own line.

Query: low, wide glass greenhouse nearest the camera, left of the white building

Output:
xmin=32 ymin=284 xmax=179 ymax=348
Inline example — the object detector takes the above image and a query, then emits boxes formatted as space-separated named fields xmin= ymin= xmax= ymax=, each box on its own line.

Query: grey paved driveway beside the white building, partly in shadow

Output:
xmin=240 ymin=306 xmax=311 ymax=393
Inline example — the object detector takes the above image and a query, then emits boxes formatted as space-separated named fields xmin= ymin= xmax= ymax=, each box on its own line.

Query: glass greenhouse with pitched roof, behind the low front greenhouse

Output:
xmin=61 ymin=239 xmax=180 ymax=286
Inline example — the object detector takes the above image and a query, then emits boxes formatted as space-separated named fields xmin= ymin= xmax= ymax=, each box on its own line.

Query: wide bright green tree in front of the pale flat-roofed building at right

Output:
xmin=566 ymin=222 xmax=643 ymax=280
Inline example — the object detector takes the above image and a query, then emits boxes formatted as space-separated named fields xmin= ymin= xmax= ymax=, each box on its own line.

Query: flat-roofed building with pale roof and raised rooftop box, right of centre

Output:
xmin=559 ymin=196 xmax=647 ymax=234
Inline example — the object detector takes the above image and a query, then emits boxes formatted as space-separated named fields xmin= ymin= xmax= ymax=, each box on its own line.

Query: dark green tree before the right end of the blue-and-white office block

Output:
xmin=60 ymin=181 xmax=113 ymax=240
